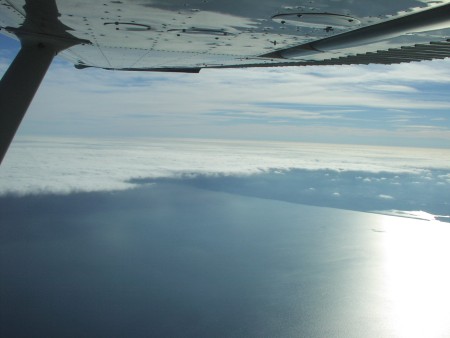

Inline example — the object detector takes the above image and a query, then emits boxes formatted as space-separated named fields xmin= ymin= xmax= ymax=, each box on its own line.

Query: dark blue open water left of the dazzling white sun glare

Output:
xmin=0 ymin=182 xmax=450 ymax=337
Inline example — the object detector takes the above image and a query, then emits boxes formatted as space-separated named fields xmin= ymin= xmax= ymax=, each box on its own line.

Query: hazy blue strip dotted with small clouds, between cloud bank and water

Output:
xmin=130 ymin=169 xmax=450 ymax=220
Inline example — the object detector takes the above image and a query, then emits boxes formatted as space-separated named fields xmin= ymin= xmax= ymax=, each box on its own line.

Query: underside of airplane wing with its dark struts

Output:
xmin=0 ymin=0 xmax=450 ymax=161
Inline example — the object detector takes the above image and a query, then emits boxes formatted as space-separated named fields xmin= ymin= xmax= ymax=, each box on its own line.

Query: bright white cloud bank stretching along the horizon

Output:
xmin=0 ymin=137 xmax=450 ymax=194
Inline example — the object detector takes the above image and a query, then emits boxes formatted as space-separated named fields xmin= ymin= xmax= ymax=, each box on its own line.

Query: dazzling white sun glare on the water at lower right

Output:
xmin=383 ymin=217 xmax=450 ymax=337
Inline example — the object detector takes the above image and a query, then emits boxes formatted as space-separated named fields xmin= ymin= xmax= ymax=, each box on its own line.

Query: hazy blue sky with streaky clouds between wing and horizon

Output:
xmin=0 ymin=36 xmax=450 ymax=148
